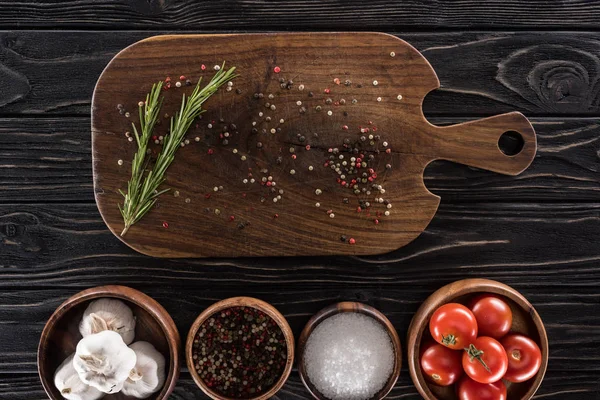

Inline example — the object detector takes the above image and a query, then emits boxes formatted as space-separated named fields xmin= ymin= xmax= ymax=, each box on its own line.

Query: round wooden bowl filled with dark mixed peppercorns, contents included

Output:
xmin=186 ymin=297 xmax=294 ymax=400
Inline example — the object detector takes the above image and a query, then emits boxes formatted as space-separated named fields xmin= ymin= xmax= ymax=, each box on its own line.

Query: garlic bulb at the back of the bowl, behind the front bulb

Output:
xmin=79 ymin=298 xmax=135 ymax=344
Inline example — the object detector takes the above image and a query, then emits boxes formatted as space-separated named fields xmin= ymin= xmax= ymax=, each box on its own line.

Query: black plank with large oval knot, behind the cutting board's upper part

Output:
xmin=0 ymin=30 xmax=600 ymax=117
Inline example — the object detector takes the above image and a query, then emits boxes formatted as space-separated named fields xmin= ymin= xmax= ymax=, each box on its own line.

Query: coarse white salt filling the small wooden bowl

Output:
xmin=304 ymin=312 xmax=395 ymax=400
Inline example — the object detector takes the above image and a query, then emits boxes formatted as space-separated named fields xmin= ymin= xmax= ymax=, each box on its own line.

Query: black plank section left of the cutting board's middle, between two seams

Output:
xmin=0 ymin=118 xmax=93 ymax=202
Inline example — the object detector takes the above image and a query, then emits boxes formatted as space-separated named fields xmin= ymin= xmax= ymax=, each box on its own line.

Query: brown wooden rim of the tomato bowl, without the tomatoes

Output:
xmin=406 ymin=278 xmax=548 ymax=400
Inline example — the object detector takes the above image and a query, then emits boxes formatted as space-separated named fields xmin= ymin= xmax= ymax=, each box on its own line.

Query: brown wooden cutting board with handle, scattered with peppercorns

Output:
xmin=92 ymin=33 xmax=536 ymax=257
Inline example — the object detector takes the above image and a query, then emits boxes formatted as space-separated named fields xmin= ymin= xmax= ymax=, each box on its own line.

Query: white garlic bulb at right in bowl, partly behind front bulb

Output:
xmin=122 ymin=342 xmax=165 ymax=399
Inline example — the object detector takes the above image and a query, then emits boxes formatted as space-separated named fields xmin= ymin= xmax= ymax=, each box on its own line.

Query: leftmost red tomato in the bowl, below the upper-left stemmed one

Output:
xmin=421 ymin=342 xmax=463 ymax=386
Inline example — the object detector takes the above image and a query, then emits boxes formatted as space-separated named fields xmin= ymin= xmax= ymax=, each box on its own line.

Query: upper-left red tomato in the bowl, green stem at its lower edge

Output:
xmin=429 ymin=303 xmax=477 ymax=350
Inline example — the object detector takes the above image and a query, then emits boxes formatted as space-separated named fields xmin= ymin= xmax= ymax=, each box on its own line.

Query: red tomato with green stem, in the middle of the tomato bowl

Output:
xmin=463 ymin=336 xmax=508 ymax=383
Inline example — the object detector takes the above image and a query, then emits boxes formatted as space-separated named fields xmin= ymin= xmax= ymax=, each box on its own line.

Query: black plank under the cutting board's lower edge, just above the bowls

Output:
xmin=0 ymin=202 xmax=600 ymax=286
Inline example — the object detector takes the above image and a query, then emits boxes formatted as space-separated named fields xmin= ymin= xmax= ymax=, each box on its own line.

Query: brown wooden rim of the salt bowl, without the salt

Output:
xmin=298 ymin=301 xmax=402 ymax=400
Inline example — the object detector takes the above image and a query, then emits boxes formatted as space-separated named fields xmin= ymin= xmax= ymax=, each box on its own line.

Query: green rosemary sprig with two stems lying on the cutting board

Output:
xmin=119 ymin=63 xmax=236 ymax=236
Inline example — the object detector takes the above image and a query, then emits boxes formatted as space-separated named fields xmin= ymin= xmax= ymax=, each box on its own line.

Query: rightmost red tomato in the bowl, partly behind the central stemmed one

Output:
xmin=500 ymin=334 xmax=542 ymax=382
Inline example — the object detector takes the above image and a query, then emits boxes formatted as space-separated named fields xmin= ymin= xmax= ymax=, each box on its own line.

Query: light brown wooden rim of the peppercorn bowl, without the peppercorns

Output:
xmin=185 ymin=297 xmax=294 ymax=400
